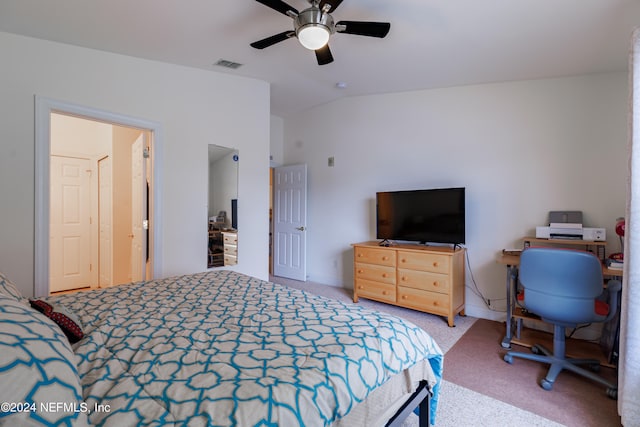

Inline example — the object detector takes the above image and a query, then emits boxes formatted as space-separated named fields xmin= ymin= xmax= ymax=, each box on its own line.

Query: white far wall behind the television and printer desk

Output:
xmin=284 ymin=73 xmax=627 ymax=318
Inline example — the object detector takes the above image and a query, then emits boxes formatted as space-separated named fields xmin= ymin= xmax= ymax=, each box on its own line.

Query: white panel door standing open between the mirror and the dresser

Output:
xmin=273 ymin=165 xmax=307 ymax=281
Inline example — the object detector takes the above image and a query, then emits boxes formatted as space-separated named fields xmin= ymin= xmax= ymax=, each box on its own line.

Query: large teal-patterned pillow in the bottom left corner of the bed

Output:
xmin=0 ymin=294 xmax=89 ymax=426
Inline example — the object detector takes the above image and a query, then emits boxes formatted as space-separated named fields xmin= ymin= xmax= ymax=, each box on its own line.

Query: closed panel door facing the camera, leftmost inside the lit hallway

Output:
xmin=49 ymin=156 xmax=91 ymax=292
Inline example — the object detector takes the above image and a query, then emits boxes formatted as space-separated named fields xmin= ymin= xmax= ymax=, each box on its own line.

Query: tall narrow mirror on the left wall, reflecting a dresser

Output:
xmin=207 ymin=144 xmax=239 ymax=268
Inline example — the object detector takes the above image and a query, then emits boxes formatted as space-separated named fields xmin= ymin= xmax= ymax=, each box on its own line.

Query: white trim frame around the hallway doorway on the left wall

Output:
xmin=34 ymin=95 xmax=163 ymax=297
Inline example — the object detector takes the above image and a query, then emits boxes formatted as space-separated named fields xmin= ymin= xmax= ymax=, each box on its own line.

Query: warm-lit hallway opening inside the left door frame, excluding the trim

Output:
xmin=49 ymin=112 xmax=152 ymax=293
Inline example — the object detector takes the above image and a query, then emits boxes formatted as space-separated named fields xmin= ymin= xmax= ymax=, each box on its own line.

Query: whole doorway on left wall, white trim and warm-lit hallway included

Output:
xmin=34 ymin=97 xmax=161 ymax=296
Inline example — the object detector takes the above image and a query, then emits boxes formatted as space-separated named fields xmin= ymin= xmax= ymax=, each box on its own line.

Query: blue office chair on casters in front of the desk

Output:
xmin=504 ymin=248 xmax=621 ymax=399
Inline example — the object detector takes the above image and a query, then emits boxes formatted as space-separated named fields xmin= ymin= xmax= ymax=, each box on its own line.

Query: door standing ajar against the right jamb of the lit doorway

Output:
xmin=130 ymin=133 xmax=146 ymax=282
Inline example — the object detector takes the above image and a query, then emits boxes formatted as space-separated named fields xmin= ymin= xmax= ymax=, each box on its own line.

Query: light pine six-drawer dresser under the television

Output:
xmin=352 ymin=242 xmax=465 ymax=326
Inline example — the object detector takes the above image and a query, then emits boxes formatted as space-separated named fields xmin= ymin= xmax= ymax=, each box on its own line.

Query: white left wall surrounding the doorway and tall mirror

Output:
xmin=0 ymin=33 xmax=270 ymax=296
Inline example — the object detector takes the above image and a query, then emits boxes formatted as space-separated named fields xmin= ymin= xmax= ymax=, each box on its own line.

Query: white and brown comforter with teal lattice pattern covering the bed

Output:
xmin=53 ymin=271 xmax=442 ymax=426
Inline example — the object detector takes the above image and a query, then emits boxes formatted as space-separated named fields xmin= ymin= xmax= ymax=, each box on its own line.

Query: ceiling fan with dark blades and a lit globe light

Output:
xmin=251 ymin=0 xmax=391 ymax=65
